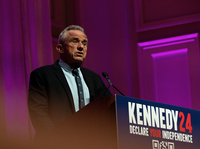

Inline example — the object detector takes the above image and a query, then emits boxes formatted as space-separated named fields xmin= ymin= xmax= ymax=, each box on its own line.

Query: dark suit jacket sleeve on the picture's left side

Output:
xmin=28 ymin=71 xmax=53 ymax=133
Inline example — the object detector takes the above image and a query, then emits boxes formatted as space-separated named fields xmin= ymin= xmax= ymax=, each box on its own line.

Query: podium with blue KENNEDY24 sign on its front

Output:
xmin=40 ymin=95 xmax=200 ymax=149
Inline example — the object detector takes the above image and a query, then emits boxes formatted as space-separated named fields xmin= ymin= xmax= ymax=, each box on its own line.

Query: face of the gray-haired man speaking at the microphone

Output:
xmin=62 ymin=30 xmax=88 ymax=68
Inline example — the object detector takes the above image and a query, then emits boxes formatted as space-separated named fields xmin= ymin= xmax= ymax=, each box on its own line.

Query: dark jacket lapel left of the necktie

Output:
xmin=53 ymin=61 xmax=75 ymax=112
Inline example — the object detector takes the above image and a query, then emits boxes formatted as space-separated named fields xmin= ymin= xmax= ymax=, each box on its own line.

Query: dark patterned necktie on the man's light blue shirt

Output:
xmin=72 ymin=69 xmax=85 ymax=109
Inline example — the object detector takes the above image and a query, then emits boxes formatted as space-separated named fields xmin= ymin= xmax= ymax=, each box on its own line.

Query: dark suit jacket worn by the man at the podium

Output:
xmin=28 ymin=61 xmax=111 ymax=135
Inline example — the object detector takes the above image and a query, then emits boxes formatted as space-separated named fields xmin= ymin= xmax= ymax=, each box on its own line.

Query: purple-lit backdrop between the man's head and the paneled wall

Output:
xmin=76 ymin=0 xmax=139 ymax=97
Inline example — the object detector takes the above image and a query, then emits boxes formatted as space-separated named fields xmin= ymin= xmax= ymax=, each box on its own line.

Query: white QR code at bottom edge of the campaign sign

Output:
xmin=152 ymin=140 xmax=175 ymax=149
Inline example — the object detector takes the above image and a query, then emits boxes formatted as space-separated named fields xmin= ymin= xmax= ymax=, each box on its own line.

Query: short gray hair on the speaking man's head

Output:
xmin=58 ymin=25 xmax=85 ymax=45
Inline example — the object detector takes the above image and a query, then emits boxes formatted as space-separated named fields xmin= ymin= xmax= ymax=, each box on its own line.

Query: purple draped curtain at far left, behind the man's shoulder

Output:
xmin=0 ymin=0 xmax=53 ymax=141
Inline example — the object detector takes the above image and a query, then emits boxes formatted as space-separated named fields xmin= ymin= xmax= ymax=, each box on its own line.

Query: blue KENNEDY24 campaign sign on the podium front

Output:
xmin=115 ymin=95 xmax=200 ymax=149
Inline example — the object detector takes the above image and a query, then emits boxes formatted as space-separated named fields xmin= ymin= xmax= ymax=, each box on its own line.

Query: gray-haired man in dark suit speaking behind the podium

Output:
xmin=28 ymin=25 xmax=111 ymax=140
